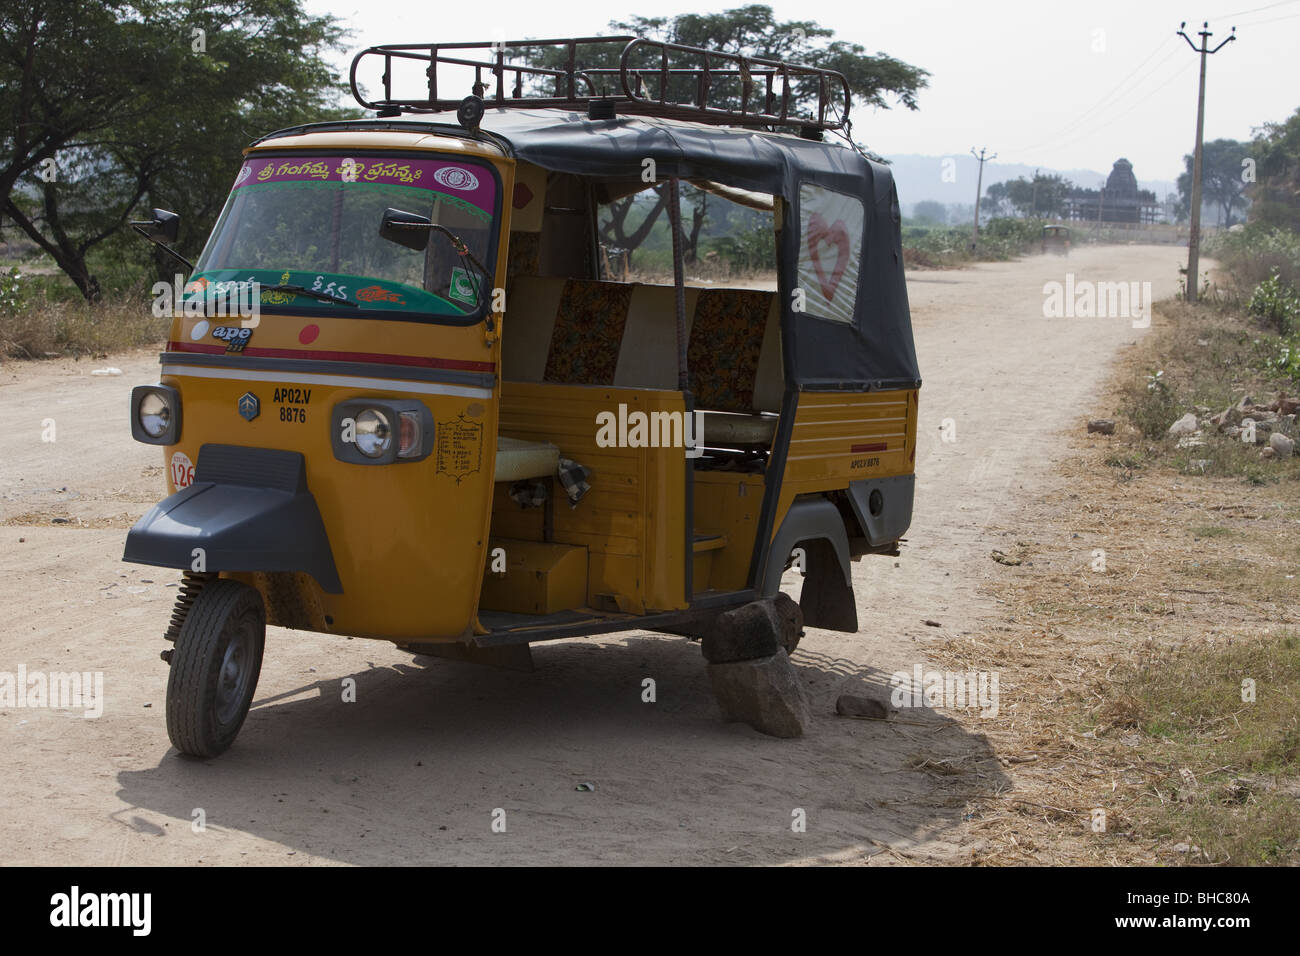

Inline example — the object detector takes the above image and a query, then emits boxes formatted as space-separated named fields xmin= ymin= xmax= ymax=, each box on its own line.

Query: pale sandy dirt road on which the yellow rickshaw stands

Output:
xmin=0 ymin=246 xmax=1179 ymax=865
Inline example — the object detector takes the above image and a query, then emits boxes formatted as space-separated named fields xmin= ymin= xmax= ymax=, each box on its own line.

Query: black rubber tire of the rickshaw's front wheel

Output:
xmin=166 ymin=579 xmax=267 ymax=757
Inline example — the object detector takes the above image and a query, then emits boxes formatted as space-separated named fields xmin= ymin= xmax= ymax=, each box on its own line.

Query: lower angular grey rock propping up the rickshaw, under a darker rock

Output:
xmin=709 ymin=648 xmax=813 ymax=737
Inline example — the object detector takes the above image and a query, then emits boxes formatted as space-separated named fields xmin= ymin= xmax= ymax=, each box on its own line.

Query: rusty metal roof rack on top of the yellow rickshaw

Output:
xmin=350 ymin=36 xmax=850 ymax=133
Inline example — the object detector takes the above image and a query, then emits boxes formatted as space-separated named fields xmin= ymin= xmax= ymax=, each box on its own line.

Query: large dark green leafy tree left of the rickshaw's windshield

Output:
xmin=0 ymin=0 xmax=341 ymax=300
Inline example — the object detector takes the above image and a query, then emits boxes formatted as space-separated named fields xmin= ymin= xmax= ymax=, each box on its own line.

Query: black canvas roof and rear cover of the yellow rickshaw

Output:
xmin=256 ymin=108 xmax=920 ymax=389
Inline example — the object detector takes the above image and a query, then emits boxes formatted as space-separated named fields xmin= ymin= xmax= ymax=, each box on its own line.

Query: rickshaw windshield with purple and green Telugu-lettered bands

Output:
xmin=187 ymin=153 xmax=498 ymax=320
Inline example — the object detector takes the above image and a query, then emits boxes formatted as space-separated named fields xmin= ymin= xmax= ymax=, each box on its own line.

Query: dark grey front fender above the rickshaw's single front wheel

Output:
xmin=122 ymin=445 xmax=343 ymax=594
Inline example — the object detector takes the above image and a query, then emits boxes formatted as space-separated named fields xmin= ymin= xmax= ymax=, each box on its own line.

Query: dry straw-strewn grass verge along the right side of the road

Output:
xmin=920 ymin=299 xmax=1300 ymax=865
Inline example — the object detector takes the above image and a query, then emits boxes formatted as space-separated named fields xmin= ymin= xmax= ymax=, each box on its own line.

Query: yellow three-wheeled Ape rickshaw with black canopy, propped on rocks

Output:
xmin=125 ymin=38 xmax=920 ymax=756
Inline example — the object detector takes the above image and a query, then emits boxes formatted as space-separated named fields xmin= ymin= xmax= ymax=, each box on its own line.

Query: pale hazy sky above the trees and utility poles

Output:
xmin=307 ymin=0 xmax=1300 ymax=179
